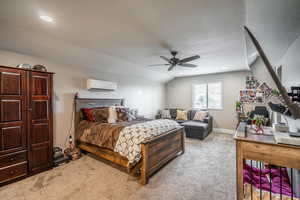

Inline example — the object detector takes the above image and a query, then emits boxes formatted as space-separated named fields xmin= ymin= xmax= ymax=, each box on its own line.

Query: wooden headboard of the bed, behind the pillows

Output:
xmin=74 ymin=98 xmax=124 ymax=138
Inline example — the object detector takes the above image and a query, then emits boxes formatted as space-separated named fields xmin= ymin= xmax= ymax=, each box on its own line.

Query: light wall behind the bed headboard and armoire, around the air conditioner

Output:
xmin=0 ymin=51 xmax=165 ymax=147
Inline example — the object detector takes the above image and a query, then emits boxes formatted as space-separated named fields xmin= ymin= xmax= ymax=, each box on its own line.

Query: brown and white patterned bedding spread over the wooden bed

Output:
xmin=76 ymin=119 xmax=181 ymax=164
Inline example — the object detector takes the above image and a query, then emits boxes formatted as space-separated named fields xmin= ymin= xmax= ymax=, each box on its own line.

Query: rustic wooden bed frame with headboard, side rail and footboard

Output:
xmin=75 ymin=98 xmax=185 ymax=185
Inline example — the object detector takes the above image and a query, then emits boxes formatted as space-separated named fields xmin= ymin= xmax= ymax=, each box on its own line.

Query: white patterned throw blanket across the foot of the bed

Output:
xmin=114 ymin=119 xmax=181 ymax=163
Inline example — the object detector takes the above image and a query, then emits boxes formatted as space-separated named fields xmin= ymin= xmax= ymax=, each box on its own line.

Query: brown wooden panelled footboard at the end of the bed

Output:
xmin=140 ymin=128 xmax=185 ymax=185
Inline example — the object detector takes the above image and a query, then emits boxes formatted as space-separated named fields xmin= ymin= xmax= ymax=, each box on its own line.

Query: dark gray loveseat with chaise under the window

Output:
xmin=156 ymin=108 xmax=213 ymax=140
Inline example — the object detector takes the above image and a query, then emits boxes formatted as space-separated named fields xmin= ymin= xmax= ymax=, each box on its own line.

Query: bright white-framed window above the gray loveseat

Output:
xmin=192 ymin=82 xmax=222 ymax=109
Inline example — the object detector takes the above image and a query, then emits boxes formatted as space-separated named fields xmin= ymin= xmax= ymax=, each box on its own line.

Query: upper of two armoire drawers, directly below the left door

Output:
xmin=0 ymin=151 xmax=27 ymax=168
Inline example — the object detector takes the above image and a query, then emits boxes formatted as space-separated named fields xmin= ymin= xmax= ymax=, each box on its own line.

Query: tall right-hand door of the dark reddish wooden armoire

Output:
xmin=28 ymin=72 xmax=53 ymax=172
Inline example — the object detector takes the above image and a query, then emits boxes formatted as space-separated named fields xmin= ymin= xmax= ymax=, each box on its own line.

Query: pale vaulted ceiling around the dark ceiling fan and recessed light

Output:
xmin=0 ymin=0 xmax=300 ymax=81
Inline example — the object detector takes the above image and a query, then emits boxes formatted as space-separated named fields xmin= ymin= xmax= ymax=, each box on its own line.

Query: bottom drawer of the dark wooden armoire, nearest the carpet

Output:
xmin=0 ymin=162 xmax=27 ymax=183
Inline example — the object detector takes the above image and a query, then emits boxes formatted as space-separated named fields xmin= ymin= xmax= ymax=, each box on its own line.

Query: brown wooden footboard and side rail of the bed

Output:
xmin=77 ymin=128 xmax=185 ymax=185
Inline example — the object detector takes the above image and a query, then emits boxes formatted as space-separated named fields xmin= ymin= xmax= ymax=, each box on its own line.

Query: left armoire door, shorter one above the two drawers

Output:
xmin=0 ymin=67 xmax=27 ymax=156
